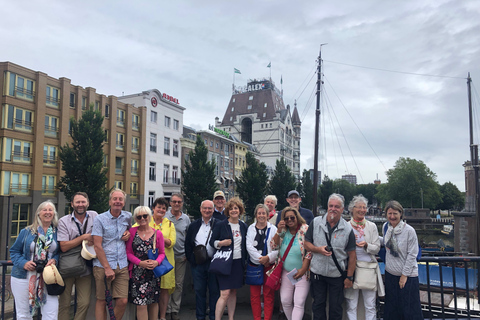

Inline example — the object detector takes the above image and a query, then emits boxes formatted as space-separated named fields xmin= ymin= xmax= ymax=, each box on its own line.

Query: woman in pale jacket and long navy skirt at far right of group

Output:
xmin=382 ymin=201 xmax=423 ymax=320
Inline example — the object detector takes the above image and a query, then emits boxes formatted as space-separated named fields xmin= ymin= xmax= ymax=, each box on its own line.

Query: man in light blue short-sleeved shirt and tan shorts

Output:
xmin=92 ymin=189 xmax=132 ymax=320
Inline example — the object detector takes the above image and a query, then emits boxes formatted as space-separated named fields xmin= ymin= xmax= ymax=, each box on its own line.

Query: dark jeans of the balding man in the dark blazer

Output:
xmin=192 ymin=261 xmax=220 ymax=320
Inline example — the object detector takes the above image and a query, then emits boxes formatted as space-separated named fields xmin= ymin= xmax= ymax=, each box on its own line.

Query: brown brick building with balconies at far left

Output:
xmin=0 ymin=62 xmax=146 ymax=257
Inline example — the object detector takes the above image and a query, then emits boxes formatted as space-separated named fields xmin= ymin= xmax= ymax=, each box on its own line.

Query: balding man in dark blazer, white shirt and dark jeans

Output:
xmin=185 ymin=200 xmax=220 ymax=320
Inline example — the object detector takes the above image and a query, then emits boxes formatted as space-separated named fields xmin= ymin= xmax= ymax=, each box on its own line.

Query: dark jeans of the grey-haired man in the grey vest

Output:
xmin=310 ymin=272 xmax=344 ymax=320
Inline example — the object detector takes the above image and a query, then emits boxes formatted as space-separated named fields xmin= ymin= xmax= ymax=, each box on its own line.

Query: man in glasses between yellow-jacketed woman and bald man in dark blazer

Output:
xmin=165 ymin=193 xmax=190 ymax=320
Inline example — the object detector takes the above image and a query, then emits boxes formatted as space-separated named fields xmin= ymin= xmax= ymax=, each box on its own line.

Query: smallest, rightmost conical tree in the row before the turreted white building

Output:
xmin=268 ymin=157 xmax=297 ymax=210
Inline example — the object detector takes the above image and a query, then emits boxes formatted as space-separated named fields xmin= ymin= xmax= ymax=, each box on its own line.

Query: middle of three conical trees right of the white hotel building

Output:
xmin=235 ymin=152 xmax=268 ymax=218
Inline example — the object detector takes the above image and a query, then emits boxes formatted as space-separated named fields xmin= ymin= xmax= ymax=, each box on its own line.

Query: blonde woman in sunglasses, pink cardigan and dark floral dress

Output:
xmin=127 ymin=206 xmax=165 ymax=320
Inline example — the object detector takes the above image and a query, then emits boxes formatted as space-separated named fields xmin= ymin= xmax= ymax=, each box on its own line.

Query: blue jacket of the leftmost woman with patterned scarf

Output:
xmin=10 ymin=228 xmax=60 ymax=279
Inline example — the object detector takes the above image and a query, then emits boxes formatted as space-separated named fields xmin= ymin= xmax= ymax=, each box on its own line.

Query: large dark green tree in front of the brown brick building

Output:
xmin=57 ymin=104 xmax=111 ymax=212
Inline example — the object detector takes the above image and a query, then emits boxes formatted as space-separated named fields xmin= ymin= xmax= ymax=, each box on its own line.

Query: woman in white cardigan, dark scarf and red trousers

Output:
xmin=247 ymin=204 xmax=278 ymax=320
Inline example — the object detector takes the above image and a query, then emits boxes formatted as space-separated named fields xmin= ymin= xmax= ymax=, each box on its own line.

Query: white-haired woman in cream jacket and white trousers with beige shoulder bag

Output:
xmin=344 ymin=194 xmax=385 ymax=320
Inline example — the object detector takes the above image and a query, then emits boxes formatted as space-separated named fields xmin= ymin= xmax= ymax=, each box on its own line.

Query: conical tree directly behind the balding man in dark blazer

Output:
xmin=182 ymin=135 xmax=217 ymax=218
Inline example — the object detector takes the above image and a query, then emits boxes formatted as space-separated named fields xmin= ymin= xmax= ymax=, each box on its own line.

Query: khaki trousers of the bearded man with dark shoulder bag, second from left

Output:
xmin=58 ymin=274 xmax=93 ymax=320
